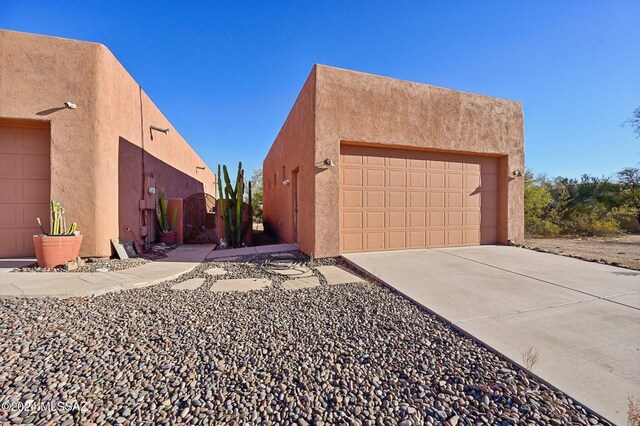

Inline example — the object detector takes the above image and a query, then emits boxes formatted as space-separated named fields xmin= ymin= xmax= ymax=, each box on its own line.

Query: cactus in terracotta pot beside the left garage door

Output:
xmin=33 ymin=200 xmax=82 ymax=268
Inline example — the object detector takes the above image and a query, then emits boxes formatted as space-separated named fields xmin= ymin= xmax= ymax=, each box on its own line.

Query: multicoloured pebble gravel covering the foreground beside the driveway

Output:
xmin=0 ymin=254 xmax=606 ymax=425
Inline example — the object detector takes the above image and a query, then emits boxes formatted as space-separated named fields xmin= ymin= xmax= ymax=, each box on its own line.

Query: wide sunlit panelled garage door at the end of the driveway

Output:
xmin=340 ymin=145 xmax=498 ymax=253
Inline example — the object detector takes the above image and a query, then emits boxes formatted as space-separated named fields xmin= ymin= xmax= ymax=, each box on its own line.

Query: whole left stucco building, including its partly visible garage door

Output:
xmin=0 ymin=31 xmax=215 ymax=258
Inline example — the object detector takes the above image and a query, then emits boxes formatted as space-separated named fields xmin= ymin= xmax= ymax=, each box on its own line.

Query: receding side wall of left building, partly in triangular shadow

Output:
xmin=97 ymin=45 xmax=216 ymax=250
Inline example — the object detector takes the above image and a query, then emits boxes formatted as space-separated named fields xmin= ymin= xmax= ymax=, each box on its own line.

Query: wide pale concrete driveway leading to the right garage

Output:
xmin=344 ymin=246 xmax=640 ymax=424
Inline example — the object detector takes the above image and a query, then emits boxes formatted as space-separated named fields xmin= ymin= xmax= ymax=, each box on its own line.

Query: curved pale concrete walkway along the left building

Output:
xmin=0 ymin=244 xmax=214 ymax=298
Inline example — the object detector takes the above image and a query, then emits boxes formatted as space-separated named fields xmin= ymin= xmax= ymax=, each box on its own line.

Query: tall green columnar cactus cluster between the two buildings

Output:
xmin=218 ymin=162 xmax=251 ymax=247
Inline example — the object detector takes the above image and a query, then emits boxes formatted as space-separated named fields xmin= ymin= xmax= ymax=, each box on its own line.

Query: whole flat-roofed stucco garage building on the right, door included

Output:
xmin=263 ymin=65 xmax=524 ymax=257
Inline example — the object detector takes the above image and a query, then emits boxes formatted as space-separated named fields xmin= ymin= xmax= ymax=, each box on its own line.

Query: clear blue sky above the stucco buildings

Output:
xmin=0 ymin=0 xmax=640 ymax=177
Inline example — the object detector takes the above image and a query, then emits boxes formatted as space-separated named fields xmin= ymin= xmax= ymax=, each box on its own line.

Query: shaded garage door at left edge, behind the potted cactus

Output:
xmin=0 ymin=123 xmax=51 ymax=258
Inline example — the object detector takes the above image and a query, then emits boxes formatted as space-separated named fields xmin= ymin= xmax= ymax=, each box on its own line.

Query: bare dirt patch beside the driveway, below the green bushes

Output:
xmin=525 ymin=235 xmax=640 ymax=270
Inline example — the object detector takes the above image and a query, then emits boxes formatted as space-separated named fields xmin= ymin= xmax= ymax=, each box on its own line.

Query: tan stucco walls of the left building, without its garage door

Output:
xmin=0 ymin=30 xmax=215 ymax=256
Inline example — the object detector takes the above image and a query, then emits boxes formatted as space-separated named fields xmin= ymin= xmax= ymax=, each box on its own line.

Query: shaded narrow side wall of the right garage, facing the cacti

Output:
xmin=263 ymin=68 xmax=317 ymax=253
